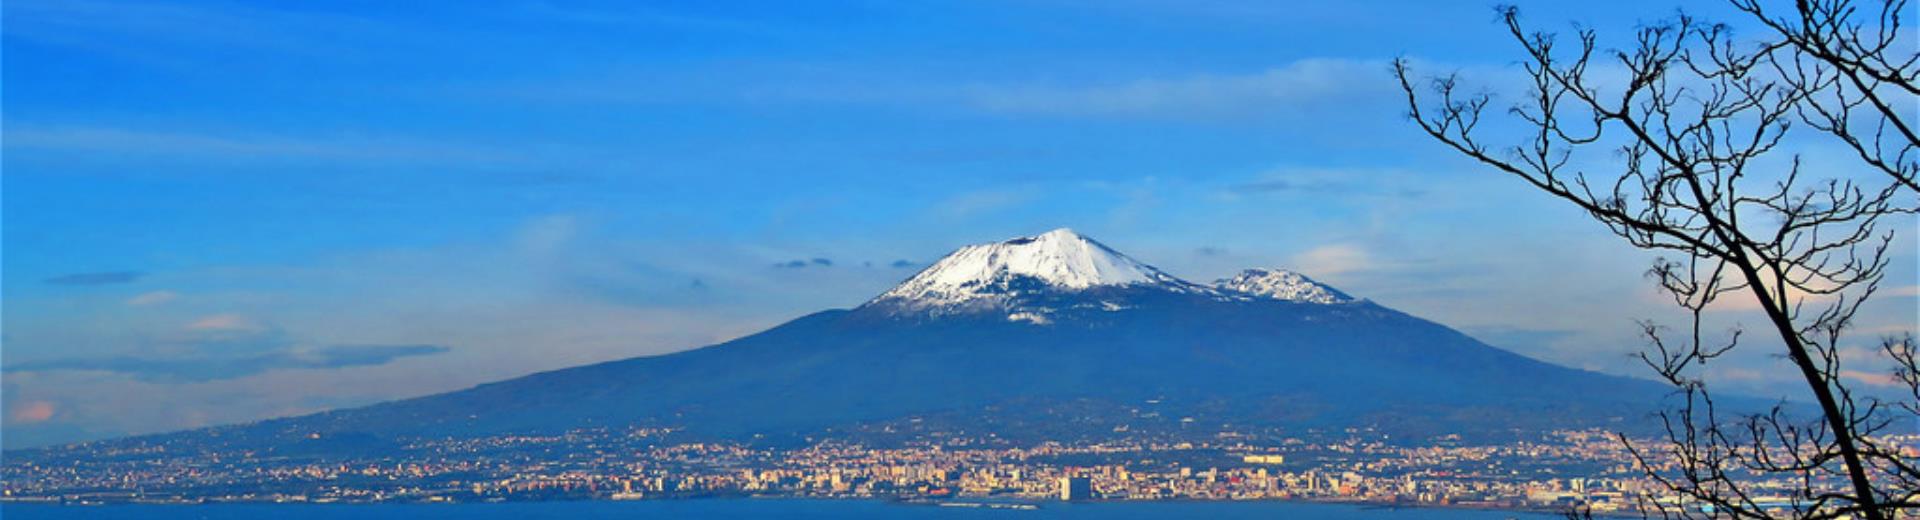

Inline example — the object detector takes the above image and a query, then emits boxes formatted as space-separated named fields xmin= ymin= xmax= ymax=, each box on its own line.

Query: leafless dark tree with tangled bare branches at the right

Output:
xmin=1394 ymin=0 xmax=1920 ymax=518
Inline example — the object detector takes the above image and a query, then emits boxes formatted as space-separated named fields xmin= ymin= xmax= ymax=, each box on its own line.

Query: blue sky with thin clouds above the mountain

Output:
xmin=0 ymin=0 xmax=1914 ymax=445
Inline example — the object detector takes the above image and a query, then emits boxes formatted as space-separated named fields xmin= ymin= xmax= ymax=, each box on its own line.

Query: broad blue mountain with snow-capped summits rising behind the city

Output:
xmin=210 ymin=230 xmax=1665 ymax=449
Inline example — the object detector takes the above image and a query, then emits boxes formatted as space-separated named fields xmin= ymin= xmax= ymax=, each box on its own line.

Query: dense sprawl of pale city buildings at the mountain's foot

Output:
xmin=11 ymin=428 xmax=1920 ymax=512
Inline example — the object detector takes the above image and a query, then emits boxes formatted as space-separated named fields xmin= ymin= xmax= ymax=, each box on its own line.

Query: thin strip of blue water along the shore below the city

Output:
xmin=0 ymin=499 xmax=1553 ymax=520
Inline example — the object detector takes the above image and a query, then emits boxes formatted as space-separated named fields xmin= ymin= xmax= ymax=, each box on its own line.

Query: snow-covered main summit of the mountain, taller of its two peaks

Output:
xmin=874 ymin=228 xmax=1204 ymax=309
